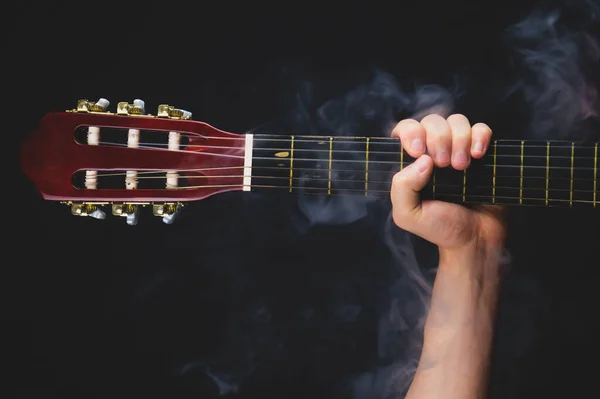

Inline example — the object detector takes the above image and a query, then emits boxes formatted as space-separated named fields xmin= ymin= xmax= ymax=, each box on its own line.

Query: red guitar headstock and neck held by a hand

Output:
xmin=21 ymin=98 xmax=600 ymax=225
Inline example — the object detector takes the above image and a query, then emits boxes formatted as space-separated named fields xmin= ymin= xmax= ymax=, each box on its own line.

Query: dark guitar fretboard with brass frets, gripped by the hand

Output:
xmin=250 ymin=134 xmax=600 ymax=207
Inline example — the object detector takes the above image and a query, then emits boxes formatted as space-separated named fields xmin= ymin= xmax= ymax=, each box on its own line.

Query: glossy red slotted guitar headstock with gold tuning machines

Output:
xmin=21 ymin=98 xmax=245 ymax=225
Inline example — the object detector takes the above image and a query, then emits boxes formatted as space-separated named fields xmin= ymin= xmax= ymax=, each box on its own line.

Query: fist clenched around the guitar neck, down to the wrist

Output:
xmin=391 ymin=114 xmax=505 ymax=255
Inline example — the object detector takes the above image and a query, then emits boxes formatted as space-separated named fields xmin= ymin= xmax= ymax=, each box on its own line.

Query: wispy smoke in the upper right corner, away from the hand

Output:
xmin=506 ymin=1 xmax=600 ymax=139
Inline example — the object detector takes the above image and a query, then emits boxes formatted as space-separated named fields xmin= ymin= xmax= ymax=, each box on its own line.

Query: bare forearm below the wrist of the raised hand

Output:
xmin=407 ymin=244 xmax=501 ymax=399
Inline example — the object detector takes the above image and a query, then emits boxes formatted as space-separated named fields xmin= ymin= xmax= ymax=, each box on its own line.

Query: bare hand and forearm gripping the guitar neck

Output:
xmin=391 ymin=114 xmax=506 ymax=399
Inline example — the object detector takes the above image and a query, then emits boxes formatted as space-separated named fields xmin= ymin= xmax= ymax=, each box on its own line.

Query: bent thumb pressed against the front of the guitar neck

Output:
xmin=391 ymin=155 xmax=433 ymax=234
